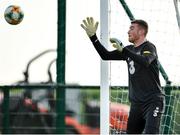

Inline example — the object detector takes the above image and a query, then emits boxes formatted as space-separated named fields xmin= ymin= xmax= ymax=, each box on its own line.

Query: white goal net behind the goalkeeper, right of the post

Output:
xmin=110 ymin=0 xmax=180 ymax=134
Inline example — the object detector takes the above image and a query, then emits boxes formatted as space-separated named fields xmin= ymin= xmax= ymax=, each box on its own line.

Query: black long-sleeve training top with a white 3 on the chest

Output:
xmin=90 ymin=35 xmax=164 ymax=103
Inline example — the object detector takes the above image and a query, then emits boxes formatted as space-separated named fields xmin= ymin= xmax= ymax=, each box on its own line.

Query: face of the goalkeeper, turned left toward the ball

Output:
xmin=128 ymin=23 xmax=141 ymax=43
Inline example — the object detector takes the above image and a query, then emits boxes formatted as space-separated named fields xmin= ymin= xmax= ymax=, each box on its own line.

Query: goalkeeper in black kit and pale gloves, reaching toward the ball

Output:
xmin=81 ymin=17 xmax=164 ymax=134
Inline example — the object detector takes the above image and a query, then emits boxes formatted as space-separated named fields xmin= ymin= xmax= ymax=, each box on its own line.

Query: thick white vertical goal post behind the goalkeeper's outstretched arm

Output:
xmin=100 ymin=0 xmax=110 ymax=135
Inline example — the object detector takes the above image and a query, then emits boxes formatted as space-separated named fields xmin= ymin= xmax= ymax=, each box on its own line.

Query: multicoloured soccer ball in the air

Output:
xmin=4 ymin=5 xmax=24 ymax=25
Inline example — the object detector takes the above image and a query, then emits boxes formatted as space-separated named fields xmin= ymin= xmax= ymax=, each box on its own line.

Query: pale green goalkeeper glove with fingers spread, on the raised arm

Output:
xmin=81 ymin=17 xmax=99 ymax=37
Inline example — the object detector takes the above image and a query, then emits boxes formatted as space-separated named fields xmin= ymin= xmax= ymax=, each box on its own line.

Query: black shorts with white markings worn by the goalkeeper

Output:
xmin=127 ymin=100 xmax=164 ymax=134
